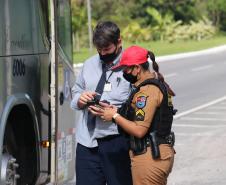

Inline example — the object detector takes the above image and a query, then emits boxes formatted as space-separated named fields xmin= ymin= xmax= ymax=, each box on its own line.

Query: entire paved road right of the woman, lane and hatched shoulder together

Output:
xmin=160 ymin=48 xmax=226 ymax=185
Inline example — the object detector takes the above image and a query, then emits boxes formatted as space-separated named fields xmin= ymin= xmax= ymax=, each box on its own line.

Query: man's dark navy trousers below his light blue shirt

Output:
xmin=76 ymin=135 xmax=132 ymax=185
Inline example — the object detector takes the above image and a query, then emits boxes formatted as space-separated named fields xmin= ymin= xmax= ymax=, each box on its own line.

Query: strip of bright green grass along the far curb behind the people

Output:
xmin=74 ymin=36 xmax=226 ymax=63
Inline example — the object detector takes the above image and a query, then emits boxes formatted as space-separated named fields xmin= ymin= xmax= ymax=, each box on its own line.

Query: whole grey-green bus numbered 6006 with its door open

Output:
xmin=0 ymin=0 xmax=75 ymax=185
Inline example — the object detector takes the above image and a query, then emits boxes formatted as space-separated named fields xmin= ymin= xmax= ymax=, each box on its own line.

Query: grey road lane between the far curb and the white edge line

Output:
xmin=159 ymin=49 xmax=226 ymax=113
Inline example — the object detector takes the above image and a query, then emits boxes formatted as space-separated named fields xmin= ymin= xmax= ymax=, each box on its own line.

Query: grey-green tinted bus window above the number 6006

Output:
xmin=0 ymin=0 xmax=47 ymax=55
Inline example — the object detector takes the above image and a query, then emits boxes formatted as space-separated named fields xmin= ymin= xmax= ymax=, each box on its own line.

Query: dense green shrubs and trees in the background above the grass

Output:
xmin=72 ymin=0 xmax=226 ymax=50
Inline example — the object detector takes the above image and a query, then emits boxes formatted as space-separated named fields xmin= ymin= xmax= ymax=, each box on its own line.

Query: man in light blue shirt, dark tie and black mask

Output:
xmin=71 ymin=21 xmax=132 ymax=185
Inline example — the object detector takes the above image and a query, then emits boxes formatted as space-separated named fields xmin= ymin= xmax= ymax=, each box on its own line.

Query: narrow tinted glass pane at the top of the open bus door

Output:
xmin=57 ymin=0 xmax=72 ymax=63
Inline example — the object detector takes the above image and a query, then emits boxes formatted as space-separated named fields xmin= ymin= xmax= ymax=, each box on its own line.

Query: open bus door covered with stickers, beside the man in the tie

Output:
xmin=50 ymin=0 xmax=75 ymax=184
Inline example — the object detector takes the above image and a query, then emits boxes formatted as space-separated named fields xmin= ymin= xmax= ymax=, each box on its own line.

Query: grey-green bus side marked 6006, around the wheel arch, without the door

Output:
xmin=0 ymin=0 xmax=49 ymax=182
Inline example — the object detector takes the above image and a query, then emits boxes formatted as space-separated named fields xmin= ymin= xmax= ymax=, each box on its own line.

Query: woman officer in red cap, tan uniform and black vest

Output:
xmin=101 ymin=46 xmax=174 ymax=185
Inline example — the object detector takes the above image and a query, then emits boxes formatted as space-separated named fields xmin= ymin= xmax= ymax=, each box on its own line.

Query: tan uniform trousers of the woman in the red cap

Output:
xmin=130 ymin=144 xmax=175 ymax=185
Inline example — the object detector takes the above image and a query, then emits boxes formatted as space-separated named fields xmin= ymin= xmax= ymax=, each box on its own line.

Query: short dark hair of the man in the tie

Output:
xmin=93 ymin=21 xmax=120 ymax=48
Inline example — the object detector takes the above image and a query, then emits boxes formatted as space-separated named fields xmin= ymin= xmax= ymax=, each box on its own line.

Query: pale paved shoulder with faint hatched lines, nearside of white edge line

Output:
xmin=168 ymin=97 xmax=226 ymax=185
